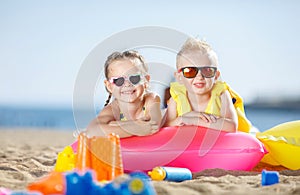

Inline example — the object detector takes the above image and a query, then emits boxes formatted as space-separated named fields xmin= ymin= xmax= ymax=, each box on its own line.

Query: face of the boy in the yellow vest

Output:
xmin=175 ymin=51 xmax=220 ymax=95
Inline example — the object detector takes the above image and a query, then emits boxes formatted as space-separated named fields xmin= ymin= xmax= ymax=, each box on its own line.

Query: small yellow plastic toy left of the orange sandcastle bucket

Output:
xmin=54 ymin=146 xmax=76 ymax=172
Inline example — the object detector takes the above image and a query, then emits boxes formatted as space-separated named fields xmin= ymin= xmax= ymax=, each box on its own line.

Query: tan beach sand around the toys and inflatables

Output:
xmin=0 ymin=129 xmax=300 ymax=195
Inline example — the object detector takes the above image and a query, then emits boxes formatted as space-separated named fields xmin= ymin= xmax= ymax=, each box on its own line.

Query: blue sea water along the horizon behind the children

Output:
xmin=0 ymin=106 xmax=300 ymax=131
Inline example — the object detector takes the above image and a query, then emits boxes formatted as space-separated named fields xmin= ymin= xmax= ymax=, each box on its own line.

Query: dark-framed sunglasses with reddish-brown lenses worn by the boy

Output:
xmin=178 ymin=66 xmax=217 ymax=79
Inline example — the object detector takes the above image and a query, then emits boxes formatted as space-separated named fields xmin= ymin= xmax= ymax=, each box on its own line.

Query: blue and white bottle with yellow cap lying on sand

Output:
xmin=148 ymin=167 xmax=192 ymax=182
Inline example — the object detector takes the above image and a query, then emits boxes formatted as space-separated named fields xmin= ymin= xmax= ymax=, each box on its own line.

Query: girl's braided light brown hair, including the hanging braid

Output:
xmin=104 ymin=50 xmax=148 ymax=106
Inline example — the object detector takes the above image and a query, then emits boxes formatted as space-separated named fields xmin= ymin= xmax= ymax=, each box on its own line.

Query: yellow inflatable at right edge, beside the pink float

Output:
xmin=256 ymin=120 xmax=300 ymax=170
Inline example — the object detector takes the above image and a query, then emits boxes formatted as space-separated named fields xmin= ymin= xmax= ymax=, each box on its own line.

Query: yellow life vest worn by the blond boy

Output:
xmin=170 ymin=81 xmax=251 ymax=133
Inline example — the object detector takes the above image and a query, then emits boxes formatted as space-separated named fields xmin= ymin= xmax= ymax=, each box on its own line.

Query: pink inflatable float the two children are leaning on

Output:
xmin=121 ymin=126 xmax=266 ymax=172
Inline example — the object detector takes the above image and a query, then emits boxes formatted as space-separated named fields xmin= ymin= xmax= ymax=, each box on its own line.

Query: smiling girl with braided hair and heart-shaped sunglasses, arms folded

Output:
xmin=87 ymin=51 xmax=161 ymax=138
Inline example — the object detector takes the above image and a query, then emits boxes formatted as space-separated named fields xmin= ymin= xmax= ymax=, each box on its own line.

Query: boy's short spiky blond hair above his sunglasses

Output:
xmin=176 ymin=37 xmax=219 ymax=67
